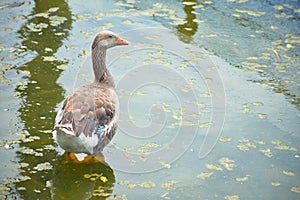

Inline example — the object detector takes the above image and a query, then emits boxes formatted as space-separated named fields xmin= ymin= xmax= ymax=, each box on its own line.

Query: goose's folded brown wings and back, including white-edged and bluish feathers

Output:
xmin=55 ymin=84 xmax=117 ymax=139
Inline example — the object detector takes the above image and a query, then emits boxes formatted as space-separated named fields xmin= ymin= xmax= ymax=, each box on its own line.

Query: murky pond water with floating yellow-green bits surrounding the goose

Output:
xmin=0 ymin=0 xmax=300 ymax=199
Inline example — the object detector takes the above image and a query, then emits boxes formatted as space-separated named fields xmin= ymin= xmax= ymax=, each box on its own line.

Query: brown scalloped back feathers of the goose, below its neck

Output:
xmin=60 ymin=83 xmax=116 ymax=137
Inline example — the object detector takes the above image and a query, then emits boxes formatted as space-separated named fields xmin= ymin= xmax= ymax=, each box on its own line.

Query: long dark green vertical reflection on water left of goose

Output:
xmin=16 ymin=0 xmax=72 ymax=199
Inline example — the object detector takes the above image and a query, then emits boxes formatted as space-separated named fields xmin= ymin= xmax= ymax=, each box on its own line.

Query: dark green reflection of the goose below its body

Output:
xmin=47 ymin=153 xmax=115 ymax=200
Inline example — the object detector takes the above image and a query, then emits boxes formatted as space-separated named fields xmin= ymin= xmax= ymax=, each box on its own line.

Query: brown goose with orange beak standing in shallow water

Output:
xmin=53 ymin=31 xmax=128 ymax=161
